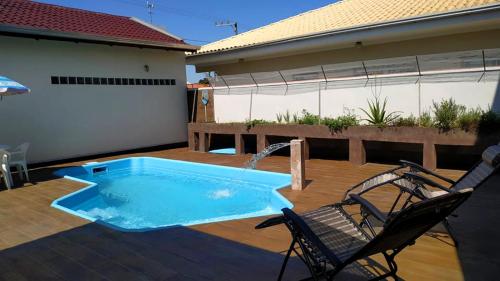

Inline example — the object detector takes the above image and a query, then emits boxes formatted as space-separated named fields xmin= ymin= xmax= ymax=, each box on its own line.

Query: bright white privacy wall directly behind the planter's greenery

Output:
xmin=214 ymin=81 xmax=500 ymax=122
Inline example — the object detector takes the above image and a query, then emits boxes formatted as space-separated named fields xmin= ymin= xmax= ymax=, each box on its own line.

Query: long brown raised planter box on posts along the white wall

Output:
xmin=188 ymin=123 xmax=500 ymax=169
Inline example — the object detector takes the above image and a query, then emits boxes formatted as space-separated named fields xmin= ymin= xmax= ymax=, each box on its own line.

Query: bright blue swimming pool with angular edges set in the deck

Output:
xmin=52 ymin=157 xmax=292 ymax=231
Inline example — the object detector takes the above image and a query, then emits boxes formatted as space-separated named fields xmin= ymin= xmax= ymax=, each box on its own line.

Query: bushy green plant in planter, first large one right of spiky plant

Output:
xmin=432 ymin=98 xmax=465 ymax=130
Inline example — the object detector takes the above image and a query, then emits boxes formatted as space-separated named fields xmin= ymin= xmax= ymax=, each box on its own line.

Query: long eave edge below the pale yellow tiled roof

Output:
xmin=187 ymin=4 xmax=500 ymax=68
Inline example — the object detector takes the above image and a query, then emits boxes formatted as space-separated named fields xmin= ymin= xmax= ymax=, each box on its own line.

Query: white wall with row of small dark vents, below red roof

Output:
xmin=0 ymin=36 xmax=187 ymax=163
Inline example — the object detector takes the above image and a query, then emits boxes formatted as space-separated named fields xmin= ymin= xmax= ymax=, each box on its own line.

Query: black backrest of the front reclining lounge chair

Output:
xmin=351 ymin=188 xmax=473 ymax=260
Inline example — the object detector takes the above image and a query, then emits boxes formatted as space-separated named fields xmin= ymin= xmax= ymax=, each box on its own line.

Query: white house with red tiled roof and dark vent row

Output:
xmin=0 ymin=0 xmax=196 ymax=163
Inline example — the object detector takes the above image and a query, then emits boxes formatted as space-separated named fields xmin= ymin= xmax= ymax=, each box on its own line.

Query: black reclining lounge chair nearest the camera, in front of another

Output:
xmin=256 ymin=189 xmax=472 ymax=280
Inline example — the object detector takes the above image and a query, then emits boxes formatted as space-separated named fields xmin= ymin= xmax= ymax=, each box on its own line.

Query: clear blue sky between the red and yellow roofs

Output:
xmin=37 ymin=0 xmax=335 ymax=82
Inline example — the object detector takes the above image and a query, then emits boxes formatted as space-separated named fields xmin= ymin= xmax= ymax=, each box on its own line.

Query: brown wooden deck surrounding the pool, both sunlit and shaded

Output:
xmin=0 ymin=148 xmax=498 ymax=280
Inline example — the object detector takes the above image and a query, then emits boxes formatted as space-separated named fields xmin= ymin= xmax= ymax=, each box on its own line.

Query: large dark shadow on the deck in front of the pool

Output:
xmin=0 ymin=221 xmax=383 ymax=280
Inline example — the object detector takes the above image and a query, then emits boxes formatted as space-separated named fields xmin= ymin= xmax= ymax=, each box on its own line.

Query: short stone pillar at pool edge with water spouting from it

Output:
xmin=290 ymin=140 xmax=306 ymax=190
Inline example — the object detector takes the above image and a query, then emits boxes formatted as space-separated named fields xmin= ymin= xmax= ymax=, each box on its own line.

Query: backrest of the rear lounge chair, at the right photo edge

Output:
xmin=451 ymin=144 xmax=500 ymax=190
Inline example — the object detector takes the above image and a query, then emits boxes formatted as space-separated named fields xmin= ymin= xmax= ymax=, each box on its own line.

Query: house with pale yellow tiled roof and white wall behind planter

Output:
xmin=187 ymin=0 xmax=500 ymax=122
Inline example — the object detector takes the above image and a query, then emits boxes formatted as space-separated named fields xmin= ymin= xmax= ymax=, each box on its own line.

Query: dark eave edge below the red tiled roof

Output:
xmin=0 ymin=24 xmax=199 ymax=52
